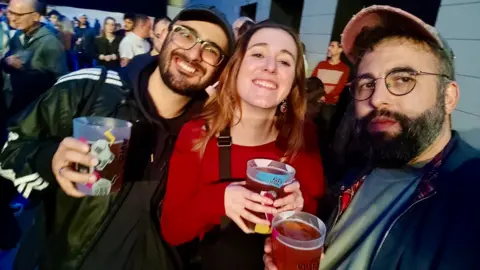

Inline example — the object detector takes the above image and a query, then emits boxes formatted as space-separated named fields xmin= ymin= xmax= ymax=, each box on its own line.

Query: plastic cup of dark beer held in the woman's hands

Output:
xmin=246 ymin=159 xmax=295 ymax=234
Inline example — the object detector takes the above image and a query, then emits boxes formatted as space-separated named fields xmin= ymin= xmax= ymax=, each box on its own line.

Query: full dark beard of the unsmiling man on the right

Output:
xmin=358 ymin=99 xmax=445 ymax=168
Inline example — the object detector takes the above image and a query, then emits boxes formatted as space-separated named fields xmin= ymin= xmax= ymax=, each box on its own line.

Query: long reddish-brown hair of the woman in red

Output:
xmin=194 ymin=22 xmax=306 ymax=159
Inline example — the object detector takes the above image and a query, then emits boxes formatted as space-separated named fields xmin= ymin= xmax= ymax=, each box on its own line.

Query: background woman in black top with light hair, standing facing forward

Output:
xmin=95 ymin=17 xmax=122 ymax=70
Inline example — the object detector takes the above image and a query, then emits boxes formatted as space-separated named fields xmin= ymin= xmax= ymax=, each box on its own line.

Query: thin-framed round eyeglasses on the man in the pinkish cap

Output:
xmin=350 ymin=68 xmax=450 ymax=101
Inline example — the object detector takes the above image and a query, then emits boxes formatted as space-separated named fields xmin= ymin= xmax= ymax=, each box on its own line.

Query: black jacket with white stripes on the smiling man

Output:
xmin=0 ymin=58 xmax=203 ymax=270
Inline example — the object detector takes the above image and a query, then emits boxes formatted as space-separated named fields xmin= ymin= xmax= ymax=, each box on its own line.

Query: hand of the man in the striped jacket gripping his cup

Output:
xmin=52 ymin=138 xmax=98 ymax=198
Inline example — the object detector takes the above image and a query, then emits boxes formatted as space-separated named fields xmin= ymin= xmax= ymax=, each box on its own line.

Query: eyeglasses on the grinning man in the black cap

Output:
xmin=171 ymin=25 xmax=225 ymax=67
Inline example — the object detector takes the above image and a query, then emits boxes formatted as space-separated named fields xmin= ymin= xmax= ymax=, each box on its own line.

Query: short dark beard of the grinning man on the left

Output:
xmin=158 ymin=41 xmax=212 ymax=98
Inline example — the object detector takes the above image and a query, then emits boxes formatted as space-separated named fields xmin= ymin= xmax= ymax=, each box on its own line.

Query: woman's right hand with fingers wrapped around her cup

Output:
xmin=225 ymin=182 xmax=277 ymax=233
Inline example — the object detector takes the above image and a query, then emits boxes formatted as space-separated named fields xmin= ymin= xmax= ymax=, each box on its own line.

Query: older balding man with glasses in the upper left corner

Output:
xmin=1 ymin=0 xmax=67 ymax=117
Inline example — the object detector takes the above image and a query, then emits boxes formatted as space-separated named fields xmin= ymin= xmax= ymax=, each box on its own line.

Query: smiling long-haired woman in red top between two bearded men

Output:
xmin=160 ymin=23 xmax=324 ymax=268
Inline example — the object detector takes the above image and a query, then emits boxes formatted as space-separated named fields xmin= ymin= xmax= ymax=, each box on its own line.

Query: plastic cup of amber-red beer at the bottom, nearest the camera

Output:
xmin=272 ymin=211 xmax=327 ymax=270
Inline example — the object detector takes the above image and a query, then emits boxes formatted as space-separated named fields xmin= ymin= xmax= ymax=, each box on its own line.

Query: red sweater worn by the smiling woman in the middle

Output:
xmin=160 ymin=120 xmax=325 ymax=245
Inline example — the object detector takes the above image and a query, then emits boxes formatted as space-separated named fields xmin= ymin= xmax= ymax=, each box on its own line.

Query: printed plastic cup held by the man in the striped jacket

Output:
xmin=73 ymin=116 xmax=132 ymax=196
